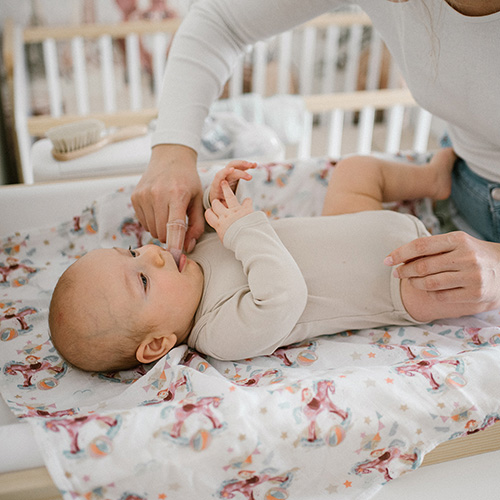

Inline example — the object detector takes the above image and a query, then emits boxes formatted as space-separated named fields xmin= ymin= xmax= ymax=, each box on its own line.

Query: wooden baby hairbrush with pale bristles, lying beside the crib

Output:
xmin=46 ymin=119 xmax=148 ymax=161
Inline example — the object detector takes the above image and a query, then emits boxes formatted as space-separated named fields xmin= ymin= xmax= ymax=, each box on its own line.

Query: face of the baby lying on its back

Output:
xmin=75 ymin=245 xmax=203 ymax=340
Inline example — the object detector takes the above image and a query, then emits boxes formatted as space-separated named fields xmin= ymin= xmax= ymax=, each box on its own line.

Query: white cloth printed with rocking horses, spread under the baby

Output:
xmin=0 ymin=154 xmax=500 ymax=500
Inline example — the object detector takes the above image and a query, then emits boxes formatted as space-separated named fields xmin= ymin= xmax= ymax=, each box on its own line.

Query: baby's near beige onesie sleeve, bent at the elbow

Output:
xmin=194 ymin=212 xmax=308 ymax=360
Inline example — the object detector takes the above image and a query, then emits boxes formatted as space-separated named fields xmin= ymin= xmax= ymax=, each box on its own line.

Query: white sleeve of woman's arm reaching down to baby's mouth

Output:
xmin=152 ymin=0 xmax=345 ymax=151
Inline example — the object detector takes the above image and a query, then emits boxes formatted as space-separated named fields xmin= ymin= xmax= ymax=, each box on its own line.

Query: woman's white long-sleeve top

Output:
xmin=153 ymin=0 xmax=500 ymax=182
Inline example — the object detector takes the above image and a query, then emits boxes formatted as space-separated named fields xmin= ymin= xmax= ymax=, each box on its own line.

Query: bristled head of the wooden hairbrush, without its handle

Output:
xmin=46 ymin=120 xmax=104 ymax=153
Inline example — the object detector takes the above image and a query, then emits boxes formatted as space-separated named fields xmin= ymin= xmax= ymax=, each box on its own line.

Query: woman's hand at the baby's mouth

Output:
xmin=131 ymin=144 xmax=205 ymax=252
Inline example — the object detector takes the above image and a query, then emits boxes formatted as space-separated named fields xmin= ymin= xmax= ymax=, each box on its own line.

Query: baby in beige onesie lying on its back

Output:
xmin=49 ymin=149 xmax=467 ymax=371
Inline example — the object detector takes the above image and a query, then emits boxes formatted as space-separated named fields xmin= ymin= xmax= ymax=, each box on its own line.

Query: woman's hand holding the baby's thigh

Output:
xmin=384 ymin=231 xmax=500 ymax=314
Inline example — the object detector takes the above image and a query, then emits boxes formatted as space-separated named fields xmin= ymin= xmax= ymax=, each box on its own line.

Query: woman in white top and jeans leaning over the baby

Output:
xmin=132 ymin=0 xmax=500 ymax=312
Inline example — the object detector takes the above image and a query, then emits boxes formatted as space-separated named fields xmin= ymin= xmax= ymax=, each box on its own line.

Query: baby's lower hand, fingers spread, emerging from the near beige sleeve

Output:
xmin=205 ymin=180 xmax=253 ymax=242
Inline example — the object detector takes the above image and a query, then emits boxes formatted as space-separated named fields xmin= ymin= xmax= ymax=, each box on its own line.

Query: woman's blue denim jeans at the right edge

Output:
xmin=441 ymin=136 xmax=500 ymax=242
